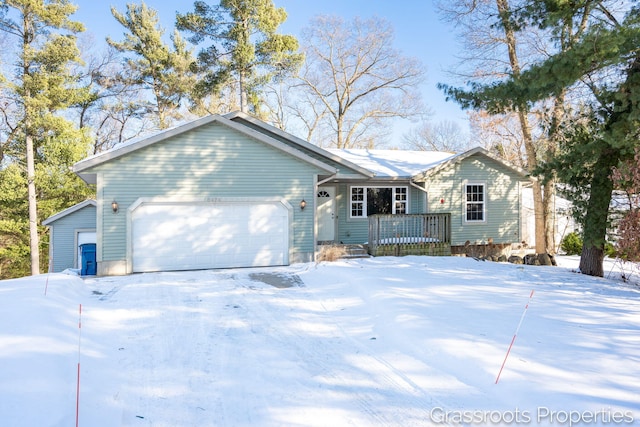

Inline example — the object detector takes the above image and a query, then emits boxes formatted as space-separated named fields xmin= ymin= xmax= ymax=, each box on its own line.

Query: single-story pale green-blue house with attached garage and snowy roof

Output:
xmin=60 ymin=113 xmax=528 ymax=275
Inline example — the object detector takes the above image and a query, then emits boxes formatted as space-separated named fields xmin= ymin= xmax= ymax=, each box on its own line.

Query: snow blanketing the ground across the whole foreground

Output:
xmin=0 ymin=256 xmax=640 ymax=427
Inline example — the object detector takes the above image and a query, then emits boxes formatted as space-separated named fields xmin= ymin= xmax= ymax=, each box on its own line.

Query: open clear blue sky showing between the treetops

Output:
xmin=74 ymin=0 xmax=467 ymax=143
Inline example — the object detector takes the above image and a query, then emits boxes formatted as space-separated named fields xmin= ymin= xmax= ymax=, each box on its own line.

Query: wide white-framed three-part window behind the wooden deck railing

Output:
xmin=349 ymin=186 xmax=409 ymax=218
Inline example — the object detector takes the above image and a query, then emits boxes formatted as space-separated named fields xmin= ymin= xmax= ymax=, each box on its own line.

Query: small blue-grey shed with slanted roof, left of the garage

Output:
xmin=42 ymin=200 xmax=97 ymax=274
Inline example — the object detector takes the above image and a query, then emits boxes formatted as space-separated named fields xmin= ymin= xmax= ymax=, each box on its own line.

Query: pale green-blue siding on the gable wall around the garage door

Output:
xmin=90 ymin=123 xmax=323 ymax=270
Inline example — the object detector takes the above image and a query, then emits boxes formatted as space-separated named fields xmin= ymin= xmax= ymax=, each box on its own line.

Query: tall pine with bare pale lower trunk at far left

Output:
xmin=0 ymin=0 xmax=91 ymax=274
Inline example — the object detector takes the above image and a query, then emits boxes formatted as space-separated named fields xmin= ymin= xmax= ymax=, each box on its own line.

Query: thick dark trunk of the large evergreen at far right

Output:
xmin=580 ymin=147 xmax=619 ymax=277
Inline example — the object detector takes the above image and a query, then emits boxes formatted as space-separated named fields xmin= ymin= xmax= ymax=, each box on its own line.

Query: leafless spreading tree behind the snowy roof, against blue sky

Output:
xmin=299 ymin=16 xmax=424 ymax=148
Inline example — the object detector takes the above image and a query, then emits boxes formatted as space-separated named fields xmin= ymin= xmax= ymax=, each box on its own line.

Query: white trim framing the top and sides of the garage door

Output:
xmin=126 ymin=196 xmax=294 ymax=274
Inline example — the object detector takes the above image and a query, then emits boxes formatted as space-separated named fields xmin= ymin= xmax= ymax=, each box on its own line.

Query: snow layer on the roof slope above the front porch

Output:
xmin=327 ymin=149 xmax=456 ymax=178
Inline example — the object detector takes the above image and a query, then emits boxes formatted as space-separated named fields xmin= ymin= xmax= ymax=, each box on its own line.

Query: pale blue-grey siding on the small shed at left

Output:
xmin=49 ymin=206 xmax=96 ymax=273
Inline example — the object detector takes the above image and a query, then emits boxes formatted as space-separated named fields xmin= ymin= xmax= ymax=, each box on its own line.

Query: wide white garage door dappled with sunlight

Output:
xmin=131 ymin=202 xmax=289 ymax=272
